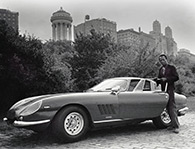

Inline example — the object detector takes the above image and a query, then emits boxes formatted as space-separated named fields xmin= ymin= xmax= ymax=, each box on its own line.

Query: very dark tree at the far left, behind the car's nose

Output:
xmin=0 ymin=21 xmax=46 ymax=111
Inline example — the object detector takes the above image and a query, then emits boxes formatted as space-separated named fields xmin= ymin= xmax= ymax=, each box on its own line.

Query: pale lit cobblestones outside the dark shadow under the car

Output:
xmin=58 ymin=112 xmax=195 ymax=149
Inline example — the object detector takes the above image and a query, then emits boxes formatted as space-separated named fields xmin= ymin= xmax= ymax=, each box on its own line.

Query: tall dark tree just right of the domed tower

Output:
xmin=71 ymin=30 xmax=115 ymax=91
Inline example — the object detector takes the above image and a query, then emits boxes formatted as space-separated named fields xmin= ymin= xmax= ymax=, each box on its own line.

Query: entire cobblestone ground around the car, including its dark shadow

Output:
xmin=0 ymin=98 xmax=195 ymax=149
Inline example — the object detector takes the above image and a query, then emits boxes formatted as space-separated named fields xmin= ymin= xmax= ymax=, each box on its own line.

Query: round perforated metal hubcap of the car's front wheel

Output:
xmin=64 ymin=112 xmax=84 ymax=136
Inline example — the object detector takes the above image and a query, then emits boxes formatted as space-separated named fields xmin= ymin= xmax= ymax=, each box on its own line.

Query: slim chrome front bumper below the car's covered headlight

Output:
xmin=13 ymin=120 xmax=50 ymax=127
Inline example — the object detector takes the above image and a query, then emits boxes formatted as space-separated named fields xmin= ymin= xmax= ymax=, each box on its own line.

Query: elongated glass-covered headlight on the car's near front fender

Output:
xmin=20 ymin=100 xmax=42 ymax=116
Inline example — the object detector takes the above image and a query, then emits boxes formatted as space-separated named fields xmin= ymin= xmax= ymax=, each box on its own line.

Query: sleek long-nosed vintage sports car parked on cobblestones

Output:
xmin=4 ymin=77 xmax=188 ymax=142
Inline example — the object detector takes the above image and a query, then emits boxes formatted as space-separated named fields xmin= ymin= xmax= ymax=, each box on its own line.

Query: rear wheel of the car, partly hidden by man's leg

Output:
xmin=153 ymin=109 xmax=171 ymax=129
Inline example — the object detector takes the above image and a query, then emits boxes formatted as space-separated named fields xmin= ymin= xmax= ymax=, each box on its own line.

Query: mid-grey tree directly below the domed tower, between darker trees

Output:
xmin=43 ymin=41 xmax=74 ymax=92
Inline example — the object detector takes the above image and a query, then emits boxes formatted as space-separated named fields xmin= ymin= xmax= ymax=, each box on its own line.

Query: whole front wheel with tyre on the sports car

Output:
xmin=52 ymin=106 xmax=89 ymax=142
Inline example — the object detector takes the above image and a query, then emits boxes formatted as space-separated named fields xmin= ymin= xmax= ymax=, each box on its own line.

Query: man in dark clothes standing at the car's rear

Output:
xmin=155 ymin=54 xmax=179 ymax=133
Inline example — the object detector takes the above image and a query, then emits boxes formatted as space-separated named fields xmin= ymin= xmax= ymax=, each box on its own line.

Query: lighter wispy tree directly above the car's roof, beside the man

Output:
xmin=98 ymin=42 xmax=158 ymax=79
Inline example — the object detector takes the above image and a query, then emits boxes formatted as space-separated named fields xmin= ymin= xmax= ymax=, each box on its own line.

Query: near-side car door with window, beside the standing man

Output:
xmin=118 ymin=79 xmax=168 ymax=119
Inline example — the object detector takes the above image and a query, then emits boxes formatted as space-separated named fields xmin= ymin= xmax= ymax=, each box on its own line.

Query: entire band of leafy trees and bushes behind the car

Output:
xmin=0 ymin=20 xmax=195 ymax=112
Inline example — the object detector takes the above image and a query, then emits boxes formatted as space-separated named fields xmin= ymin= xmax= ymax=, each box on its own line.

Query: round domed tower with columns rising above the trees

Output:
xmin=50 ymin=7 xmax=72 ymax=41
